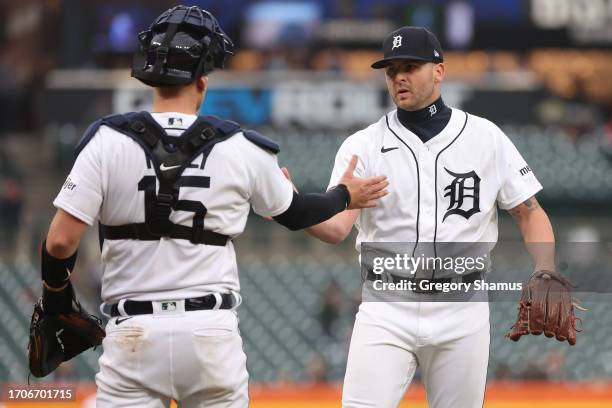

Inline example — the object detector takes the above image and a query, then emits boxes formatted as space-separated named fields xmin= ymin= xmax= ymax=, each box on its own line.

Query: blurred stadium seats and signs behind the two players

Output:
xmin=0 ymin=0 xmax=612 ymax=408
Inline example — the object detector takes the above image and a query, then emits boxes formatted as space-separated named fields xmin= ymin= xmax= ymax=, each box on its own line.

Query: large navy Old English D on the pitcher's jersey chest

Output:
xmin=442 ymin=167 xmax=480 ymax=222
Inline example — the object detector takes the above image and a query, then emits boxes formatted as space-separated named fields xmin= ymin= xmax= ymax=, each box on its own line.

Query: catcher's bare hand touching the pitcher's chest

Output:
xmin=338 ymin=155 xmax=389 ymax=210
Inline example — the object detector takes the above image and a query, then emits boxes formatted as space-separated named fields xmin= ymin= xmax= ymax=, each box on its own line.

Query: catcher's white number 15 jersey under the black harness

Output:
xmin=53 ymin=113 xmax=293 ymax=303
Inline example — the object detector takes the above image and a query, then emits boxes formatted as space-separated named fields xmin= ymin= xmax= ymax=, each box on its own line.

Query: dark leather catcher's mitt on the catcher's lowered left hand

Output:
xmin=28 ymin=288 xmax=106 ymax=377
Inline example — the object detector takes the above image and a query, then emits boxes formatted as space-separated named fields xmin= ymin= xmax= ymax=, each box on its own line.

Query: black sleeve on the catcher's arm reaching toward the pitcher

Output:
xmin=274 ymin=184 xmax=351 ymax=231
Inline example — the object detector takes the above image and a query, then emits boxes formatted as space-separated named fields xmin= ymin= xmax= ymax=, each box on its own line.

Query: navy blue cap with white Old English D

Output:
xmin=372 ymin=26 xmax=444 ymax=69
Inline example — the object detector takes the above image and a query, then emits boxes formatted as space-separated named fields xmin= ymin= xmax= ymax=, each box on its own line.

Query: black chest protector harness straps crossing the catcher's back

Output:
xmin=100 ymin=112 xmax=240 ymax=246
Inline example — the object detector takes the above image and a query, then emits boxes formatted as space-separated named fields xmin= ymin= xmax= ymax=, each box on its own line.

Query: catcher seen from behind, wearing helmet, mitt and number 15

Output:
xmin=30 ymin=6 xmax=388 ymax=408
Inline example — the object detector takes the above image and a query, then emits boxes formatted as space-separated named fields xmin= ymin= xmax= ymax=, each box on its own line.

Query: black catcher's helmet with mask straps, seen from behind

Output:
xmin=132 ymin=6 xmax=234 ymax=86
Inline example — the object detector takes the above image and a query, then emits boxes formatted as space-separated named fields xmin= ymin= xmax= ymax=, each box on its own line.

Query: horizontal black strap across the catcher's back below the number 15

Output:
xmin=100 ymin=223 xmax=229 ymax=246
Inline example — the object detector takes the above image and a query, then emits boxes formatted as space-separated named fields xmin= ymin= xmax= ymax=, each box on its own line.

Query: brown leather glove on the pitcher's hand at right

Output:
xmin=506 ymin=271 xmax=580 ymax=346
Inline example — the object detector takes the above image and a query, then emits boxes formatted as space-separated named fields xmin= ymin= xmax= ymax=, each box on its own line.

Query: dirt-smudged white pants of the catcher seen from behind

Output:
xmin=96 ymin=310 xmax=249 ymax=408
